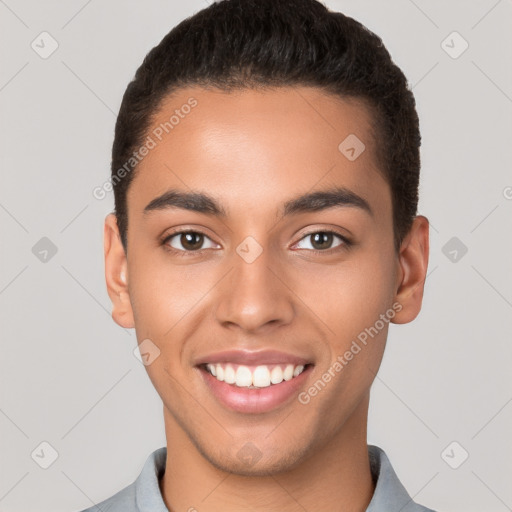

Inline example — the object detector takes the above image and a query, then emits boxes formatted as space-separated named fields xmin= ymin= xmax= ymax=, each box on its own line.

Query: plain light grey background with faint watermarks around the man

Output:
xmin=0 ymin=0 xmax=512 ymax=512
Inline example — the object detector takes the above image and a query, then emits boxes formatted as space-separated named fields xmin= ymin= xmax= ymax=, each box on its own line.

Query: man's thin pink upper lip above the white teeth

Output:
xmin=196 ymin=349 xmax=311 ymax=366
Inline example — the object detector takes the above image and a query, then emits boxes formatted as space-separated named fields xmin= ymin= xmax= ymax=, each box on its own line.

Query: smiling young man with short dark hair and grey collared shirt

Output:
xmin=81 ymin=0 xmax=436 ymax=512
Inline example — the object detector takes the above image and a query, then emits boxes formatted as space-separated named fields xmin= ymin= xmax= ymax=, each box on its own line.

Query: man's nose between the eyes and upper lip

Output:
xmin=216 ymin=247 xmax=295 ymax=333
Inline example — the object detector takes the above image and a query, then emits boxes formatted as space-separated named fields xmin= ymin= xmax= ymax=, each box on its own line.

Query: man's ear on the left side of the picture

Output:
xmin=103 ymin=213 xmax=135 ymax=329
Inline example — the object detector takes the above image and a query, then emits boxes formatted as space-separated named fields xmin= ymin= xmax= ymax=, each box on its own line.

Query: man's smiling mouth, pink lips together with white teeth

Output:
xmin=196 ymin=352 xmax=314 ymax=414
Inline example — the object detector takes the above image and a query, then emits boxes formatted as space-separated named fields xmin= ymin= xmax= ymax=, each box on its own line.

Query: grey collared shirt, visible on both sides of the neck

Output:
xmin=82 ymin=445 xmax=434 ymax=512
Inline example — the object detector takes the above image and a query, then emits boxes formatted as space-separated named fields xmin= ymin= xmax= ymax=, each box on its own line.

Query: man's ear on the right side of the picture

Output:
xmin=391 ymin=215 xmax=429 ymax=324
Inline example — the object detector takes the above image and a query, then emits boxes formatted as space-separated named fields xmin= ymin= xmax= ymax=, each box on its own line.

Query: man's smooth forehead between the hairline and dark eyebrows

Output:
xmin=128 ymin=87 xmax=391 ymax=220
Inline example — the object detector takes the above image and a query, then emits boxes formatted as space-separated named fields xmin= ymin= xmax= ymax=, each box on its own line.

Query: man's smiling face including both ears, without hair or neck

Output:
xmin=105 ymin=87 xmax=428 ymax=475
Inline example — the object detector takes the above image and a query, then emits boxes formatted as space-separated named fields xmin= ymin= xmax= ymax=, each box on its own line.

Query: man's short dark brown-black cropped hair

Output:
xmin=111 ymin=0 xmax=421 ymax=252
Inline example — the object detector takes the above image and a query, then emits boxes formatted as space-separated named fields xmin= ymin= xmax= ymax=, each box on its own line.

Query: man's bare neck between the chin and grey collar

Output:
xmin=160 ymin=397 xmax=374 ymax=512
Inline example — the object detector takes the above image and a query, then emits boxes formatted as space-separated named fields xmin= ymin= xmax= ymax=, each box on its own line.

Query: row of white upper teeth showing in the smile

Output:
xmin=206 ymin=363 xmax=304 ymax=388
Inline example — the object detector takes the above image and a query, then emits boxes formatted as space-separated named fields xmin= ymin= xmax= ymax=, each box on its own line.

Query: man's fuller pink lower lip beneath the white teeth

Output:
xmin=199 ymin=365 xmax=312 ymax=414
